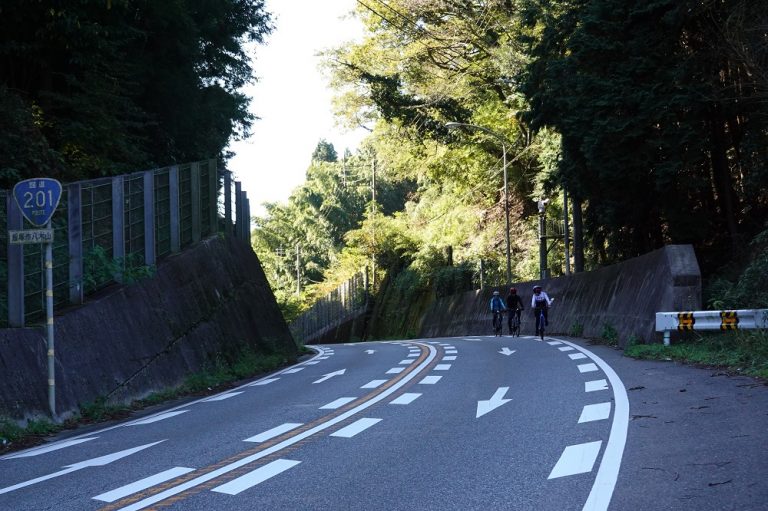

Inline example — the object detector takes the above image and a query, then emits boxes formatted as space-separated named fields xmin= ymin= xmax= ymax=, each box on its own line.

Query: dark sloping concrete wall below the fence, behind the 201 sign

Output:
xmin=0 ymin=237 xmax=297 ymax=419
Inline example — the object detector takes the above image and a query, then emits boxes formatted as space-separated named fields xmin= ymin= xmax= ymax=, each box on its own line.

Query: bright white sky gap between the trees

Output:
xmin=229 ymin=0 xmax=366 ymax=215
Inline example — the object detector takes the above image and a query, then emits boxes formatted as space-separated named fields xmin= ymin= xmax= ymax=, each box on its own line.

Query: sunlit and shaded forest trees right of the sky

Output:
xmin=255 ymin=0 xmax=768 ymax=318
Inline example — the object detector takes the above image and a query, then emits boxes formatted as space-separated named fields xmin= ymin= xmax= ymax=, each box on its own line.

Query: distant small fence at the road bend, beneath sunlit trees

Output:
xmin=289 ymin=272 xmax=369 ymax=343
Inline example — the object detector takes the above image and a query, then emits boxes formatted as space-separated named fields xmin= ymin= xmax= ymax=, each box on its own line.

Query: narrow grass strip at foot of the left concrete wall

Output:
xmin=0 ymin=348 xmax=294 ymax=453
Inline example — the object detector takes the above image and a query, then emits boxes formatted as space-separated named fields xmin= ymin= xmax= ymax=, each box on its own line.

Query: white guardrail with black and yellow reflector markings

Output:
xmin=656 ymin=309 xmax=768 ymax=346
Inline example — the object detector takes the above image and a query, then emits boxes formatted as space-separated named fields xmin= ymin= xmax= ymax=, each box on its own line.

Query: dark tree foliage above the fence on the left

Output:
xmin=0 ymin=0 xmax=272 ymax=189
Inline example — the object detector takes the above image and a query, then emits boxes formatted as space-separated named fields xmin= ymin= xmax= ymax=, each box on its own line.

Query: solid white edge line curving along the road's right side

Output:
xmin=561 ymin=339 xmax=629 ymax=511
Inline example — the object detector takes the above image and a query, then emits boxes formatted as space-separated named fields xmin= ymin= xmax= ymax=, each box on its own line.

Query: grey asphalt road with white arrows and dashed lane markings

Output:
xmin=0 ymin=337 xmax=768 ymax=511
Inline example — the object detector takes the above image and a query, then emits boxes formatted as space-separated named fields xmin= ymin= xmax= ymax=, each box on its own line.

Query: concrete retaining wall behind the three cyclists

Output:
xmin=420 ymin=245 xmax=701 ymax=346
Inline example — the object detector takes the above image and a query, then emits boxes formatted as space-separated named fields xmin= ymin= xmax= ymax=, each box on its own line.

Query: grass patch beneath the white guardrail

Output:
xmin=624 ymin=330 xmax=768 ymax=379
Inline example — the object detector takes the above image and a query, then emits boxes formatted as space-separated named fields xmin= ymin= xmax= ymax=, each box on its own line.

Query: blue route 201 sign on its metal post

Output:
xmin=9 ymin=178 xmax=61 ymax=418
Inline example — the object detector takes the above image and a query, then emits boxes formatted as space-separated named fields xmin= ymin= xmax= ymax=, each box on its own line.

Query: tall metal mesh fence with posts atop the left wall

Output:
xmin=0 ymin=160 xmax=250 ymax=327
